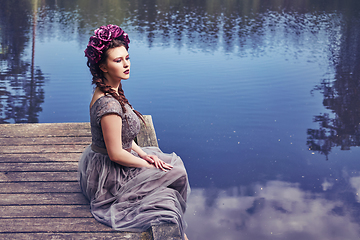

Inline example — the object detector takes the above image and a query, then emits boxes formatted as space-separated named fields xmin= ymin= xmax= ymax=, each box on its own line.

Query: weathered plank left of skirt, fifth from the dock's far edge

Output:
xmin=0 ymin=162 xmax=78 ymax=172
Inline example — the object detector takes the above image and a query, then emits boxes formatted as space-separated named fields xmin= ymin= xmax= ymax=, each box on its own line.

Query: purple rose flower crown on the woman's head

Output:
xmin=84 ymin=24 xmax=130 ymax=64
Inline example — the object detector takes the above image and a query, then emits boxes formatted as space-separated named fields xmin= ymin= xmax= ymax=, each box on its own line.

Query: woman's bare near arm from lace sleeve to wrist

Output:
xmin=100 ymin=114 xmax=154 ymax=168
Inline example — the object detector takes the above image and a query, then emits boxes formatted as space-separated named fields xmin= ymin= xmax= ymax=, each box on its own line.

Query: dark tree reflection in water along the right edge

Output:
xmin=307 ymin=5 xmax=360 ymax=159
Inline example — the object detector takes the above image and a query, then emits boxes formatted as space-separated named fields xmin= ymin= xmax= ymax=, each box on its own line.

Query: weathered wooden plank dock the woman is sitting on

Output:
xmin=0 ymin=115 xmax=181 ymax=240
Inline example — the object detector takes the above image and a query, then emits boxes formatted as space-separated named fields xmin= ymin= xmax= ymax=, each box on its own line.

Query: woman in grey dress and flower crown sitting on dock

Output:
xmin=79 ymin=25 xmax=190 ymax=239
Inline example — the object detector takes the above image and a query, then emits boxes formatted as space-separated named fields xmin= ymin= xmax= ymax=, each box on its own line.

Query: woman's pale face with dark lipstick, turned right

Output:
xmin=100 ymin=46 xmax=130 ymax=81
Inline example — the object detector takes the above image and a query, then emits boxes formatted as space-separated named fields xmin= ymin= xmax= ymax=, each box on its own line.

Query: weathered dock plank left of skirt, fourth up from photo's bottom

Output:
xmin=0 ymin=192 xmax=89 ymax=205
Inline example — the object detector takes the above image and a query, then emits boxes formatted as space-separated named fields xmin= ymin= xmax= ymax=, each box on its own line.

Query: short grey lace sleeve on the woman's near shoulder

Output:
xmin=95 ymin=96 xmax=123 ymax=125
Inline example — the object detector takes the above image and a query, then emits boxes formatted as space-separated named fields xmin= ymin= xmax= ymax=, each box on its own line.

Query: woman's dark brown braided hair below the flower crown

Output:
xmin=87 ymin=39 xmax=145 ymax=124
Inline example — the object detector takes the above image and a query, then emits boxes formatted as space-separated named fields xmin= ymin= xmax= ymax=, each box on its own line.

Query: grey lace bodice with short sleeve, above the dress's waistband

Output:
xmin=90 ymin=95 xmax=140 ymax=149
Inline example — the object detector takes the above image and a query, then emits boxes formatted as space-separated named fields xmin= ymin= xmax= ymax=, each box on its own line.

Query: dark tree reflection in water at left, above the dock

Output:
xmin=0 ymin=0 xmax=45 ymax=123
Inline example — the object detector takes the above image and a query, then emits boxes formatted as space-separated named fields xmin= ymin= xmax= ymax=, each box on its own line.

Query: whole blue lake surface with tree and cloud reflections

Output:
xmin=0 ymin=0 xmax=360 ymax=240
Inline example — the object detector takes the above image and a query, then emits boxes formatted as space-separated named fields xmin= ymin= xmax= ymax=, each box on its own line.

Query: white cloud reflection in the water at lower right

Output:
xmin=186 ymin=177 xmax=360 ymax=240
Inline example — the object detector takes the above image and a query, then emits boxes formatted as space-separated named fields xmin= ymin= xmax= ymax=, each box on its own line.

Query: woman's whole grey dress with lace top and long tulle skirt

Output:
xmin=78 ymin=95 xmax=190 ymax=234
